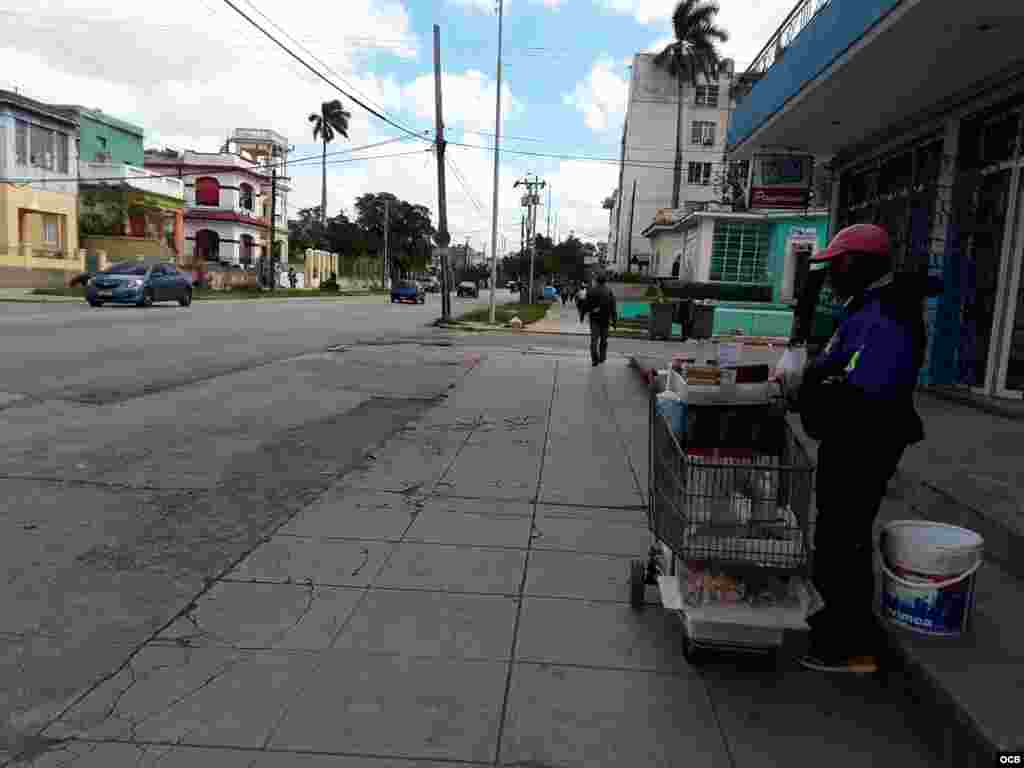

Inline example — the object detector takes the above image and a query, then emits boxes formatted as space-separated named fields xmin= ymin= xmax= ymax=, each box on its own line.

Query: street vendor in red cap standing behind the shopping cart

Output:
xmin=781 ymin=224 xmax=927 ymax=673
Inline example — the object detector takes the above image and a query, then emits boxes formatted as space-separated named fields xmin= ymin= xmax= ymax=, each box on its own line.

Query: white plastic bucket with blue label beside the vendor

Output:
xmin=878 ymin=520 xmax=984 ymax=637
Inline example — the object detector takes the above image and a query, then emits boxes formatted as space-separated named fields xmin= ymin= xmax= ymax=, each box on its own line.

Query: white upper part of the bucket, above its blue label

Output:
xmin=881 ymin=520 xmax=985 ymax=577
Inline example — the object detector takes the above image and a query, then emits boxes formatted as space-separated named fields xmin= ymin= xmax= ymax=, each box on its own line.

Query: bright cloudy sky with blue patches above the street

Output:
xmin=0 ymin=0 xmax=795 ymax=256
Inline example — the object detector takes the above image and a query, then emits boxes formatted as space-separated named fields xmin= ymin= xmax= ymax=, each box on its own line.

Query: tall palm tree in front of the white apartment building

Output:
xmin=654 ymin=0 xmax=729 ymax=208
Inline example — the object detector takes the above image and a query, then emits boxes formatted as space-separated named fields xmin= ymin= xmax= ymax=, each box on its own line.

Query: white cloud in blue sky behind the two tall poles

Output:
xmin=402 ymin=70 xmax=522 ymax=131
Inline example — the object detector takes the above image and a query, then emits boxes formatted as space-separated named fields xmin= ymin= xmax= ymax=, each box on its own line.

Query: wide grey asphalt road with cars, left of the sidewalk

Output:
xmin=0 ymin=292 xmax=516 ymax=753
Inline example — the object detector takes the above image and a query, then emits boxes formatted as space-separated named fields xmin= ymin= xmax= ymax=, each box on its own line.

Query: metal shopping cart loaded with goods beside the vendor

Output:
xmin=630 ymin=386 xmax=819 ymax=663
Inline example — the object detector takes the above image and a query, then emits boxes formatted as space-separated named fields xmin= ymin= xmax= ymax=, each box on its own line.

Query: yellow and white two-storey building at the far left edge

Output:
xmin=0 ymin=90 xmax=85 ymax=288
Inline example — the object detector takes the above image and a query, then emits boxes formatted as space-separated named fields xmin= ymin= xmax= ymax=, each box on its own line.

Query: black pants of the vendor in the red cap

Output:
xmin=808 ymin=440 xmax=904 ymax=657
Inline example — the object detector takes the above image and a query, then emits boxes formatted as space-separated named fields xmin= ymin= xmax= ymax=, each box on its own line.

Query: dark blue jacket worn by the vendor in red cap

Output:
xmin=799 ymin=275 xmax=927 ymax=450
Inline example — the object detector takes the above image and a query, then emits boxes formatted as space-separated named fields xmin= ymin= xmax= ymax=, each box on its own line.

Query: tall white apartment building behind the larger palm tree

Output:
xmin=608 ymin=53 xmax=741 ymax=275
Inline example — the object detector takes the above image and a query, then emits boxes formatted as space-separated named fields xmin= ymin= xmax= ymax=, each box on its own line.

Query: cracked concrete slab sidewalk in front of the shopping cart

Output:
xmin=15 ymin=351 xmax=933 ymax=768
